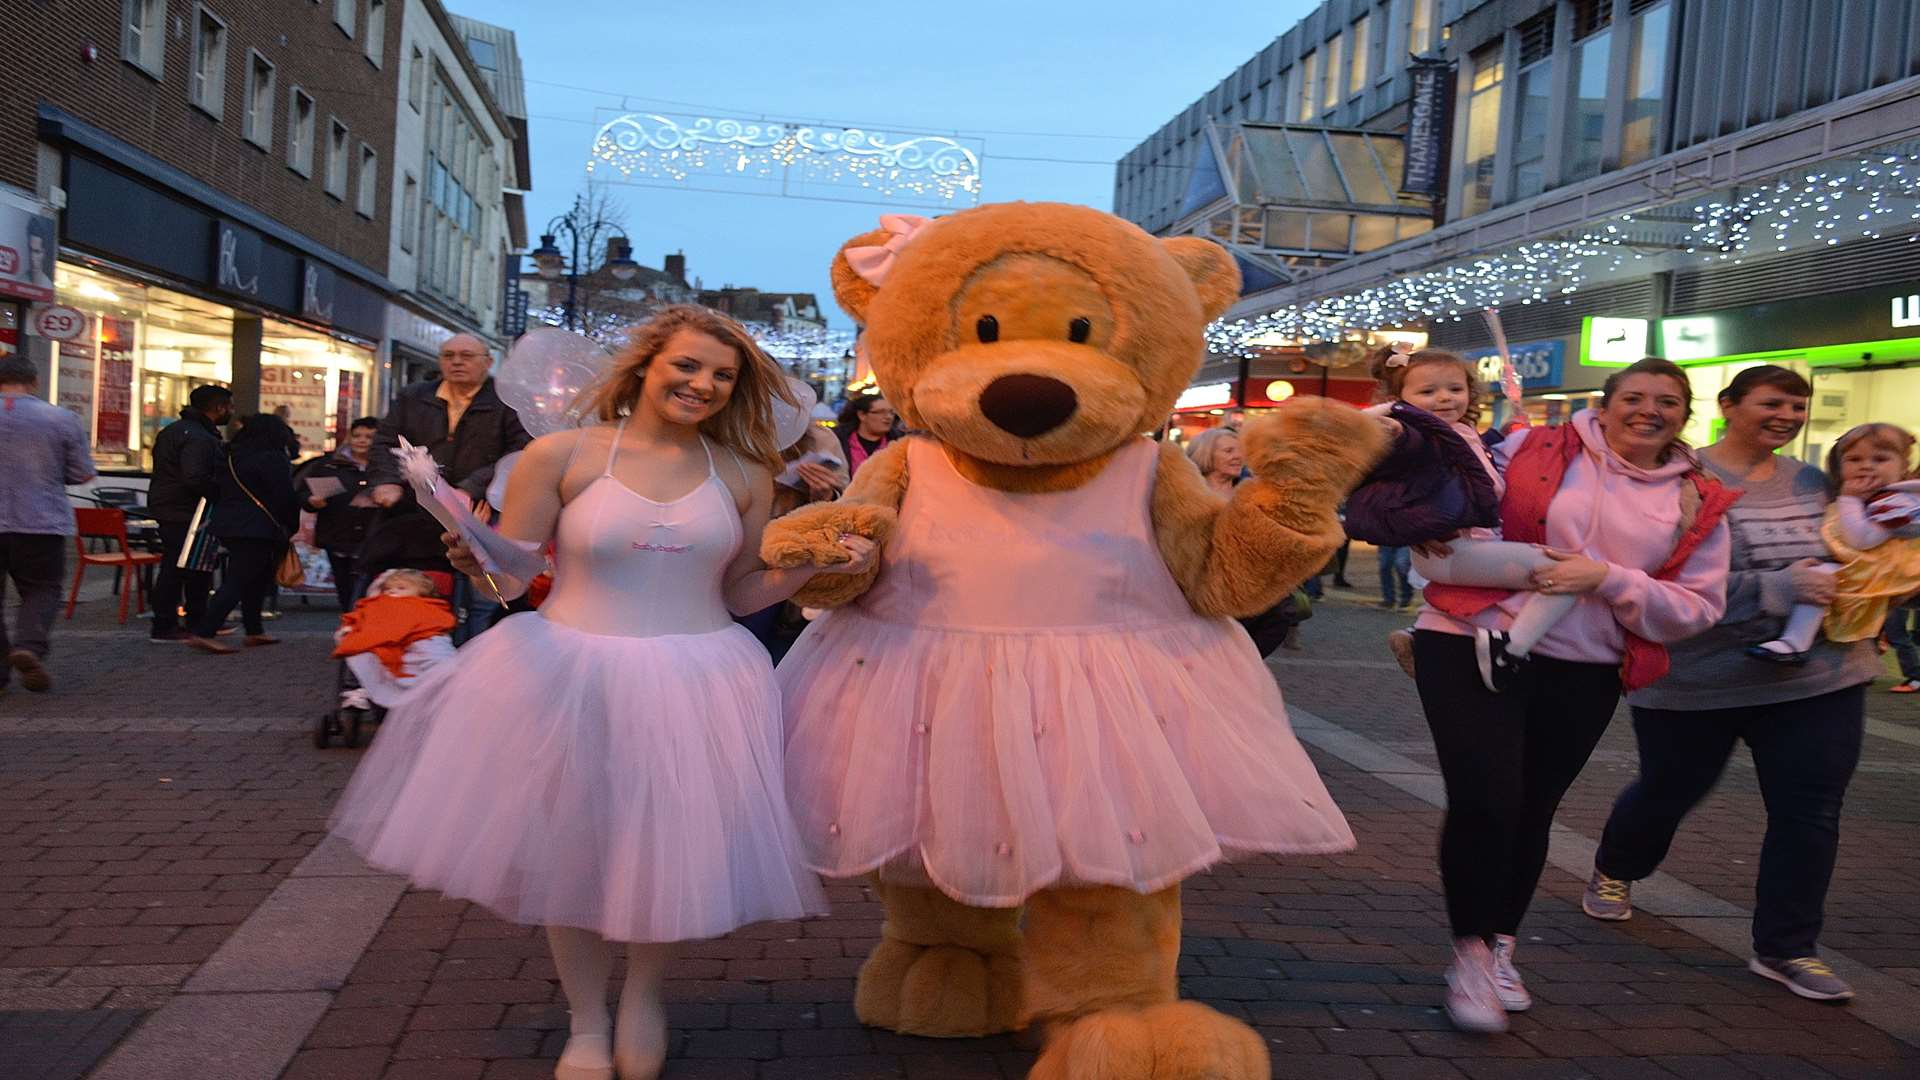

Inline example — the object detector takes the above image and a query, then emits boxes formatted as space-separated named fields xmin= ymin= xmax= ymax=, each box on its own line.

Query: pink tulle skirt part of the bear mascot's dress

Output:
xmin=780 ymin=609 xmax=1354 ymax=907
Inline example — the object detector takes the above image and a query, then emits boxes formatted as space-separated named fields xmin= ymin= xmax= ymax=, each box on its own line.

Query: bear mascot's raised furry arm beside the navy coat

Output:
xmin=1152 ymin=400 xmax=1384 ymax=617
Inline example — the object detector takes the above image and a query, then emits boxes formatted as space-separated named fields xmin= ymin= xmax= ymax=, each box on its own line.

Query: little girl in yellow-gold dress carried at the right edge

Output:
xmin=1747 ymin=423 xmax=1920 ymax=663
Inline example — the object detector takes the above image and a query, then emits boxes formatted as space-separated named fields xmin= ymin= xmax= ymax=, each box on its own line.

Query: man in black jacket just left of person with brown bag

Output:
xmin=146 ymin=384 xmax=234 ymax=642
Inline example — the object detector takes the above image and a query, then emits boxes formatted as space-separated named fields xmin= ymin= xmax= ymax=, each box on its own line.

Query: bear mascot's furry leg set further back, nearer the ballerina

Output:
xmin=854 ymin=878 xmax=1021 ymax=1038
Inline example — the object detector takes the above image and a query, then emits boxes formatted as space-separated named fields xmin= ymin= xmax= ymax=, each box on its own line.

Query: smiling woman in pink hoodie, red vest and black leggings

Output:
xmin=1413 ymin=359 xmax=1736 ymax=1032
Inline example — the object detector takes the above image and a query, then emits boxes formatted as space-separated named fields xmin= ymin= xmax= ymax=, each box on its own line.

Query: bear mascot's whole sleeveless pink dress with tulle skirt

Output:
xmin=780 ymin=438 xmax=1354 ymax=907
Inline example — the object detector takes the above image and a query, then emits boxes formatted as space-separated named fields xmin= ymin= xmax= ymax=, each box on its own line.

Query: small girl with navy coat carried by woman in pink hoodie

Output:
xmin=1346 ymin=342 xmax=1580 ymax=694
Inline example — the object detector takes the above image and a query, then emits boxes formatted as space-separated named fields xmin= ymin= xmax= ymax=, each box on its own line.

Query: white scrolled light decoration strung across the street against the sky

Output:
xmin=588 ymin=113 xmax=979 ymax=206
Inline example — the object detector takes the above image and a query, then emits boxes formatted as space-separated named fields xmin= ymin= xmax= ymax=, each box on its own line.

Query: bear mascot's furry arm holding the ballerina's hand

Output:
xmin=760 ymin=442 xmax=906 ymax=607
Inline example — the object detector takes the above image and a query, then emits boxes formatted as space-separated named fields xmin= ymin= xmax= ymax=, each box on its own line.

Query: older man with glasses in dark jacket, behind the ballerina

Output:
xmin=359 ymin=334 xmax=534 ymax=577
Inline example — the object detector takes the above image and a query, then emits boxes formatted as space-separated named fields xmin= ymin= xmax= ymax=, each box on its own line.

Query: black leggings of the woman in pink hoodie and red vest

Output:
xmin=1413 ymin=630 xmax=1620 ymax=938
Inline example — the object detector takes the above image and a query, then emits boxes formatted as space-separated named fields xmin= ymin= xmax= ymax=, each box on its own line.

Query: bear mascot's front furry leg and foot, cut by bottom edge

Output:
xmin=1025 ymin=886 xmax=1269 ymax=1080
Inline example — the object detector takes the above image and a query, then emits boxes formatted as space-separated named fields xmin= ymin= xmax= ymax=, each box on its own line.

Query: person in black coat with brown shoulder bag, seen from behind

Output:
xmin=186 ymin=413 xmax=300 ymax=653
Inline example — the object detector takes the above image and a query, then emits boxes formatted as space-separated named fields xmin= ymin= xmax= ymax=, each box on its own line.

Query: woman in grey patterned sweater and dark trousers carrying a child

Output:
xmin=1582 ymin=365 xmax=1880 ymax=999
